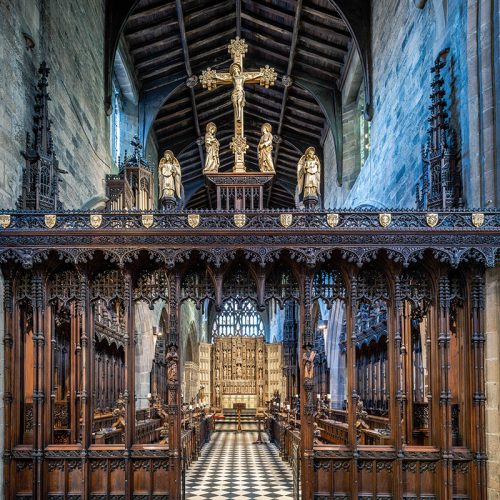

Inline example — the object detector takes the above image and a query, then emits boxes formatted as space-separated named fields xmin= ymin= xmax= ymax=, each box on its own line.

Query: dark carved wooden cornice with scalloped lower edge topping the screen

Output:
xmin=0 ymin=210 xmax=500 ymax=268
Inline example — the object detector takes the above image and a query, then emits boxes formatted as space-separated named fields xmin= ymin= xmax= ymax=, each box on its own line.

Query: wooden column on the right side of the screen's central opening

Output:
xmin=299 ymin=270 xmax=315 ymax=499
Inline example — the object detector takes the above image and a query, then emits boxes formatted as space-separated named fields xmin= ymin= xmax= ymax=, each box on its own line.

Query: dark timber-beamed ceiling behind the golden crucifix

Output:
xmin=124 ymin=0 xmax=360 ymax=208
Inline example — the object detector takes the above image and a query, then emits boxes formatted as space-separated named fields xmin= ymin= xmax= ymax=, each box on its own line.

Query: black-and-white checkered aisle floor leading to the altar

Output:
xmin=186 ymin=430 xmax=293 ymax=500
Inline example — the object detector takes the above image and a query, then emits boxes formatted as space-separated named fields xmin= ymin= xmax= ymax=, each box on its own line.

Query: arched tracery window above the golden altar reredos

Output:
xmin=212 ymin=299 xmax=264 ymax=337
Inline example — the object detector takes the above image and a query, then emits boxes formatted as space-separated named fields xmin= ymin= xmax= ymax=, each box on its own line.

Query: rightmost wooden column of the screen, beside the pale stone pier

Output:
xmin=470 ymin=271 xmax=486 ymax=500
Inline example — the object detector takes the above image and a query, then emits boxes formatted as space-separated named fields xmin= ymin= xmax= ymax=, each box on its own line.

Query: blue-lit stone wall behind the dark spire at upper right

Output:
xmin=336 ymin=0 xmax=468 ymax=208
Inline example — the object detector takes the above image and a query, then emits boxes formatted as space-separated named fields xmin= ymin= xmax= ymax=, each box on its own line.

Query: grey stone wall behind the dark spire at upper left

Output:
xmin=0 ymin=0 xmax=111 ymax=208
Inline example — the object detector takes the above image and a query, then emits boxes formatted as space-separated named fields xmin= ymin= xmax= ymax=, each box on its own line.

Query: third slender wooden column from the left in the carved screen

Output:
xmin=79 ymin=273 xmax=94 ymax=498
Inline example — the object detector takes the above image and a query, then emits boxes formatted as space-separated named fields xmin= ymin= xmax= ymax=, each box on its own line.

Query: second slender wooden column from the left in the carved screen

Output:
xmin=32 ymin=272 xmax=45 ymax=498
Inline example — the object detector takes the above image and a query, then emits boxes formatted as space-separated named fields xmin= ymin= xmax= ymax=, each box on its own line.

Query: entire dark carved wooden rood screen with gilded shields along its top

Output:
xmin=0 ymin=211 xmax=500 ymax=500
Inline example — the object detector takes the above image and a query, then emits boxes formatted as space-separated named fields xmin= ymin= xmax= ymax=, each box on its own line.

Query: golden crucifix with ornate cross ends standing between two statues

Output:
xmin=200 ymin=37 xmax=277 ymax=172
